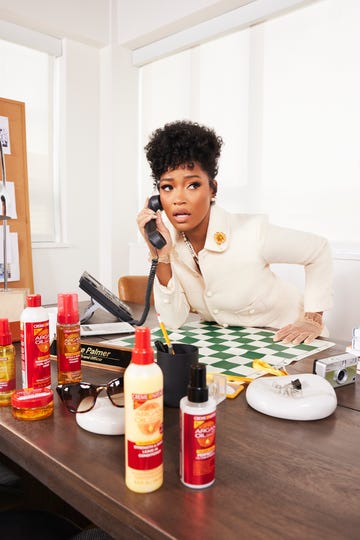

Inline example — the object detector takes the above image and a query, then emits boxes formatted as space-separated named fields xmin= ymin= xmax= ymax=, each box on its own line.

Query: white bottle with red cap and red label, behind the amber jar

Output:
xmin=20 ymin=294 xmax=51 ymax=388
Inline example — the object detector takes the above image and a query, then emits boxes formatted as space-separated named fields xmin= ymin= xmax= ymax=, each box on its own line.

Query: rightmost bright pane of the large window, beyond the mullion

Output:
xmin=258 ymin=0 xmax=360 ymax=242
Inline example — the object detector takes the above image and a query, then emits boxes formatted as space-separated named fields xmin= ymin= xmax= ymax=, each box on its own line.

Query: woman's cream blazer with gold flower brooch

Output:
xmin=154 ymin=205 xmax=333 ymax=328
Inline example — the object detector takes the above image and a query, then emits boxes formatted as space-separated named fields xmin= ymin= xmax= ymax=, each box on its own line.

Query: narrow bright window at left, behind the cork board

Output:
xmin=0 ymin=40 xmax=56 ymax=242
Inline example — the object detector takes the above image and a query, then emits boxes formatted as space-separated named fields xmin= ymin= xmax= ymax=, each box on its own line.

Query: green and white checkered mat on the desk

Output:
xmin=106 ymin=322 xmax=334 ymax=377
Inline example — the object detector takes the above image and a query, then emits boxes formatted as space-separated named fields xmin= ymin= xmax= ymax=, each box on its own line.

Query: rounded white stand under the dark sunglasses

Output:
xmin=76 ymin=396 xmax=125 ymax=435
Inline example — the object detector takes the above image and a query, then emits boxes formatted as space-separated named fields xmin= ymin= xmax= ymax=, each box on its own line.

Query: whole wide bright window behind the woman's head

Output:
xmin=141 ymin=0 xmax=360 ymax=245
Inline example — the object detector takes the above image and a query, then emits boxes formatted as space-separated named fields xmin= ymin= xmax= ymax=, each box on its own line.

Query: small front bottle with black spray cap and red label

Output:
xmin=180 ymin=364 xmax=216 ymax=488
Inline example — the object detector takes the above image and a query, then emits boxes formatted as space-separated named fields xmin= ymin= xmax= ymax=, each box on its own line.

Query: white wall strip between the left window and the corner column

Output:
xmin=33 ymin=40 xmax=100 ymax=303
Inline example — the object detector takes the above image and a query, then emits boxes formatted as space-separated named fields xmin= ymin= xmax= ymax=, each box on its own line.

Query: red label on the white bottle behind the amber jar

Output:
xmin=21 ymin=321 xmax=51 ymax=388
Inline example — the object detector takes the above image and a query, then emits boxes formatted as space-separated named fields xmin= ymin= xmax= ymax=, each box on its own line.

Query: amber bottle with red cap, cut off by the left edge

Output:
xmin=0 ymin=319 xmax=16 ymax=407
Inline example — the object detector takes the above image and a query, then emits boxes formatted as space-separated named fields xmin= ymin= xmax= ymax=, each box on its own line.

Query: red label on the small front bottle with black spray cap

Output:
xmin=180 ymin=411 xmax=216 ymax=486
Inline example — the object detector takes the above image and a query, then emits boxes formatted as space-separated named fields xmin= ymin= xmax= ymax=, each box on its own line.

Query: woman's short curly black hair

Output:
xmin=145 ymin=120 xmax=223 ymax=184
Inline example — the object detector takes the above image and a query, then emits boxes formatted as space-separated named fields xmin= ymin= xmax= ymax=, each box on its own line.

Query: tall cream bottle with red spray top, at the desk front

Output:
xmin=124 ymin=327 xmax=163 ymax=493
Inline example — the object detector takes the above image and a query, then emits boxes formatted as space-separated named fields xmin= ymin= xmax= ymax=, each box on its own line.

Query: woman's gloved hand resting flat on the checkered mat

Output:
xmin=274 ymin=313 xmax=324 ymax=345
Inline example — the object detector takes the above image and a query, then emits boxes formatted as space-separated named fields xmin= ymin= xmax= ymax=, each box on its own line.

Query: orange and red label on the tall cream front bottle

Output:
xmin=127 ymin=390 xmax=163 ymax=471
